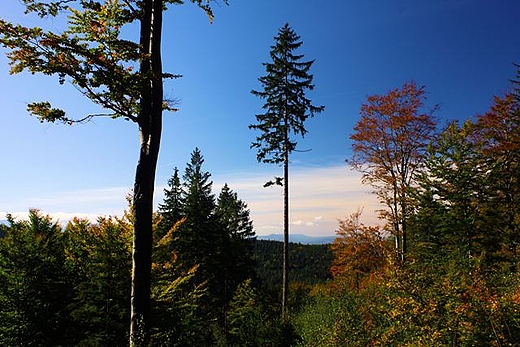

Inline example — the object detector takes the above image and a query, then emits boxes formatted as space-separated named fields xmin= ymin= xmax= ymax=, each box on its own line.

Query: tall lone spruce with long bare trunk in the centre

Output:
xmin=249 ymin=24 xmax=324 ymax=317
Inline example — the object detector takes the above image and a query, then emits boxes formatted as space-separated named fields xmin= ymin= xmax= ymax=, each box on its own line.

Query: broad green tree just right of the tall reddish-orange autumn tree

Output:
xmin=414 ymin=121 xmax=500 ymax=257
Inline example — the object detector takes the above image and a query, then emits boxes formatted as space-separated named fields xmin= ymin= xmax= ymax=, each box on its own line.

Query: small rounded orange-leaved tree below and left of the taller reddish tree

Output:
xmin=330 ymin=211 xmax=388 ymax=289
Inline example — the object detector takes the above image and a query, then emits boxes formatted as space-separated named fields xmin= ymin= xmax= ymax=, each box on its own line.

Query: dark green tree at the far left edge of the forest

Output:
xmin=0 ymin=210 xmax=72 ymax=346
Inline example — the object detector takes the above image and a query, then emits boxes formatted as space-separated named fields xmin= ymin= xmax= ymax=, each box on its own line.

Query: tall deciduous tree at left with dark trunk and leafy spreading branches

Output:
xmin=0 ymin=0 xmax=226 ymax=345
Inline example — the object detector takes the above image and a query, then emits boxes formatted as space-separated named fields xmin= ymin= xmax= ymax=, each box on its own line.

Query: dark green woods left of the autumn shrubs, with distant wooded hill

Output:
xmin=0 ymin=149 xmax=332 ymax=346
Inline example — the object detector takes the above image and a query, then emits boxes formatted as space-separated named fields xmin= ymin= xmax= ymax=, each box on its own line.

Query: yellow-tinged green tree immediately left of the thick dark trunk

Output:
xmin=65 ymin=218 xmax=132 ymax=346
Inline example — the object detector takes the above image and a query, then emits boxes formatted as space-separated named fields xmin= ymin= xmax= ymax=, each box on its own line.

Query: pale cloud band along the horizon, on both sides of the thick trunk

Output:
xmin=0 ymin=165 xmax=380 ymax=236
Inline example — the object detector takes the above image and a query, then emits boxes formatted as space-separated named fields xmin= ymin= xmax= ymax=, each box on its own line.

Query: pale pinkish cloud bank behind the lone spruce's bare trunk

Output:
xmin=215 ymin=166 xmax=380 ymax=236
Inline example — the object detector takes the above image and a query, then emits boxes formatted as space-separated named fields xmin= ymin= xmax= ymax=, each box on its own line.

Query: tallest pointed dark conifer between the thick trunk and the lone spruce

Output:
xmin=176 ymin=148 xmax=236 ymax=339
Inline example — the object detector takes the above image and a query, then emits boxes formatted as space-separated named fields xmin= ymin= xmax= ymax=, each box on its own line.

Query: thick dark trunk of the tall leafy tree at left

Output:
xmin=130 ymin=0 xmax=163 ymax=347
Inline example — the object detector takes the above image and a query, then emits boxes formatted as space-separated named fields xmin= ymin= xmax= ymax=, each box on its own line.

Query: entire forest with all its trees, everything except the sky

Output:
xmin=0 ymin=0 xmax=520 ymax=347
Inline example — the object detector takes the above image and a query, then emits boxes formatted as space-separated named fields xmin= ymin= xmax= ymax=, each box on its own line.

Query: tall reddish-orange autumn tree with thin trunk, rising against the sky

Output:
xmin=349 ymin=82 xmax=435 ymax=261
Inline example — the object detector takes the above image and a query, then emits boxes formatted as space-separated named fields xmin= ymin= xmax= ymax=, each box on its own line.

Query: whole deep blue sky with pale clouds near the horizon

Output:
xmin=0 ymin=0 xmax=520 ymax=235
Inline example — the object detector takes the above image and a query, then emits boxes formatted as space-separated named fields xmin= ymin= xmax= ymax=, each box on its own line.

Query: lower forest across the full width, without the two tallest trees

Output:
xmin=4 ymin=72 xmax=520 ymax=346
